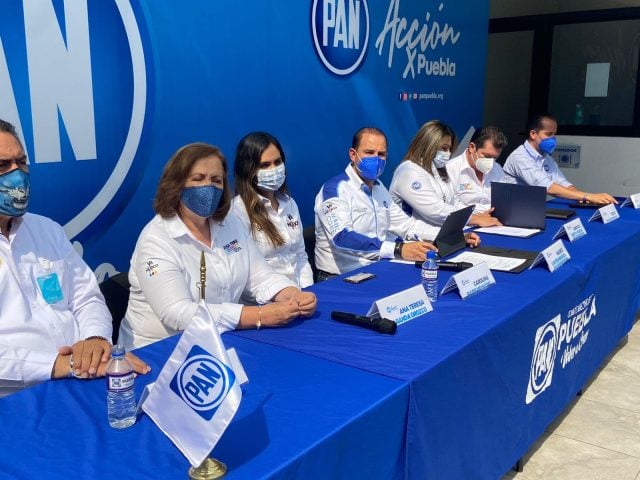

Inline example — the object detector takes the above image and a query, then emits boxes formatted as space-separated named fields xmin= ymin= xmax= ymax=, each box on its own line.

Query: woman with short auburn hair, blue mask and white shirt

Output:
xmin=120 ymin=143 xmax=316 ymax=349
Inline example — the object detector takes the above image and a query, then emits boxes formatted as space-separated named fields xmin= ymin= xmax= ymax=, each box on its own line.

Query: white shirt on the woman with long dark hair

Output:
xmin=232 ymin=192 xmax=313 ymax=288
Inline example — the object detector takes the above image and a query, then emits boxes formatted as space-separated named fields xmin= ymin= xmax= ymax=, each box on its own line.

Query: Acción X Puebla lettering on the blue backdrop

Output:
xmin=375 ymin=0 xmax=460 ymax=78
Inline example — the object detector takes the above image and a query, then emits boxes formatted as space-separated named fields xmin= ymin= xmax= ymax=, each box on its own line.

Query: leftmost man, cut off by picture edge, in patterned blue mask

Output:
xmin=0 ymin=120 xmax=149 ymax=396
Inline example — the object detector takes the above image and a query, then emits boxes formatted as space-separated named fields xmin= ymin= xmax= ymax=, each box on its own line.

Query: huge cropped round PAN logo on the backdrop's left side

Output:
xmin=0 ymin=0 xmax=147 ymax=244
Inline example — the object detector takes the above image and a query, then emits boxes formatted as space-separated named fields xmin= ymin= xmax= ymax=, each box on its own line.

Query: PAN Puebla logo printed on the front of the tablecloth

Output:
xmin=525 ymin=294 xmax=597 ymax=404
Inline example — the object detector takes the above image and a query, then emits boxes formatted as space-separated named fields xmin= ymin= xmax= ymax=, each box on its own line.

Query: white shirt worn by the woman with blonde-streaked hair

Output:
xmin=389 ymin=160 xmax=464 ymax=227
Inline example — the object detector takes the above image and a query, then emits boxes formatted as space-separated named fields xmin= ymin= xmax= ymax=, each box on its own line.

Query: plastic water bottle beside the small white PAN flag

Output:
xmin=106 ymin=345 xmax=136 ymax=428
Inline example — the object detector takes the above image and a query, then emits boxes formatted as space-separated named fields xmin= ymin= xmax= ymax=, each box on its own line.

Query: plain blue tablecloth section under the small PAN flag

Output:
xmin=0 ymin=335 xmax=408 ymax=479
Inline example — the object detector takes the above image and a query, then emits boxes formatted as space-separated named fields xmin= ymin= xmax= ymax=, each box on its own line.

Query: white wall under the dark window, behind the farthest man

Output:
xmin=558 ymin=135 xmax=640 ymax=196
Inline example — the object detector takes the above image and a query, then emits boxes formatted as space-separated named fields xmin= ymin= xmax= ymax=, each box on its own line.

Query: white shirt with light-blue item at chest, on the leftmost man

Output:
xmin=0 ymin=213 xmax=112 ymax=396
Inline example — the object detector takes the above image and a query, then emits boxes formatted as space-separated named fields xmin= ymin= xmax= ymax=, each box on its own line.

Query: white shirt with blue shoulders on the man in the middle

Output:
xmin=315 ymin=165 xmax=440 ymax=274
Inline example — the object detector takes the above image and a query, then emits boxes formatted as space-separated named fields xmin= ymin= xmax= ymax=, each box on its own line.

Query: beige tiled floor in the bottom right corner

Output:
xmin=502 ymin=321 xmax=640 ymax=480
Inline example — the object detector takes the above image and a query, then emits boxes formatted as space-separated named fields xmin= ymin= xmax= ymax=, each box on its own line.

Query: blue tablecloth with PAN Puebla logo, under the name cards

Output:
xmin=233 ymin=204 xmax=640 ymax=480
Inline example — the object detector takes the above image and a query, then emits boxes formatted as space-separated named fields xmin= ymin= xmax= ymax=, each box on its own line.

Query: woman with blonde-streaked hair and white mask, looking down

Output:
xmin=389 ymin=120 xmax=495 ymax=227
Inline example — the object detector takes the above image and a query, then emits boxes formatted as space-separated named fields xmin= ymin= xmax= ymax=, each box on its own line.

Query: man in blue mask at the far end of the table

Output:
xmin=504 ymin=114 xmax=618 ymax=205
